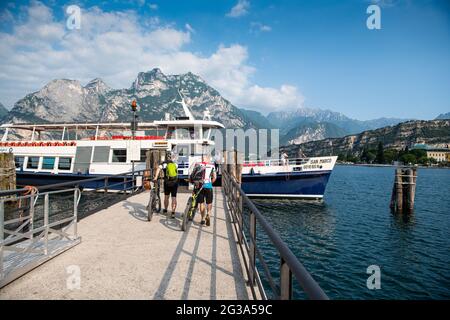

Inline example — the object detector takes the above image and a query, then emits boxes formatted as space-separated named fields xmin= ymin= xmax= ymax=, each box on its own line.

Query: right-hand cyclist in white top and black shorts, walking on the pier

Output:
xmin=192 ymin=155 xmax=217 ymax=226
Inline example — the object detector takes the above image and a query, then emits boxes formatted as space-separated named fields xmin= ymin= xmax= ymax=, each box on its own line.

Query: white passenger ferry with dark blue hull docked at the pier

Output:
xmin=0 ymin=101 xmax=337 ymax=199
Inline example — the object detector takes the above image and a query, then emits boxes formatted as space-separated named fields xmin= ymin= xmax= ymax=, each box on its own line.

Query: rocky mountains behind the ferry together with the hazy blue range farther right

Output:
xmin=0 ymin=68 xmax=440 ymax=144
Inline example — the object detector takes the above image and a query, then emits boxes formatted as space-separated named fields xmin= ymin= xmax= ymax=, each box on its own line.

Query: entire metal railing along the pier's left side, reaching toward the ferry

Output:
xmin=0 ymin=170 xmax=150 ymax=287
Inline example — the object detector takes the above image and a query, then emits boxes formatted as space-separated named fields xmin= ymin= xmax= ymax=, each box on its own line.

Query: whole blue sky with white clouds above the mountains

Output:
xmin=0 ymin=0 xmax=450 ymax=120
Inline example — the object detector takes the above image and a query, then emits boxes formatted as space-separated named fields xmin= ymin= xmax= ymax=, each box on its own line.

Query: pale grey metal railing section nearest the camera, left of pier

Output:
xmin=0 ymin=188 xmax=81 ymax=287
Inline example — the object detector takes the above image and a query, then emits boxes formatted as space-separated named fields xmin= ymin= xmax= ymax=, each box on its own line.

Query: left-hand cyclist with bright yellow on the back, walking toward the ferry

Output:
xmin=154 ymin=152 xmax=178 ymax=218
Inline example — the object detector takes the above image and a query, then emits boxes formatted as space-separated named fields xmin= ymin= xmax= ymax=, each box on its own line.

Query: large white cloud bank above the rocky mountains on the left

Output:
xmin=0 ymin=2 xmax=303 ymax=112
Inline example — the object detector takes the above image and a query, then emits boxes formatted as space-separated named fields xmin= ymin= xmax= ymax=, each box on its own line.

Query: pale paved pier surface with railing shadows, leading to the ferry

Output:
xmin=0 ymin=188 xmax=249 ymax=300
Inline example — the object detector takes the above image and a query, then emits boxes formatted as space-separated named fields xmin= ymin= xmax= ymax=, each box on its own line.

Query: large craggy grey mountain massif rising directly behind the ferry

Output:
xmin=3 ymin=69 xmax=251 ymax=128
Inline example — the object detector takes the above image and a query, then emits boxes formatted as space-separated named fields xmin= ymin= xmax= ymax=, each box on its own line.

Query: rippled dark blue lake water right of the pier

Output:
xmin=255 ymin=166 xmax=450 ymax=299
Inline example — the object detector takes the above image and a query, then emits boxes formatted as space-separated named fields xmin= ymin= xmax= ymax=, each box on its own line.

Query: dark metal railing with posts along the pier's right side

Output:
xmin=222 ymin=170 xmax=328 ymax=300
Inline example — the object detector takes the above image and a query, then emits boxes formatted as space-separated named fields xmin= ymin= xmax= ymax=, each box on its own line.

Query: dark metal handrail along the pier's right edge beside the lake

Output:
xmin=222 ymin=170 xmax=328 ymax=300
